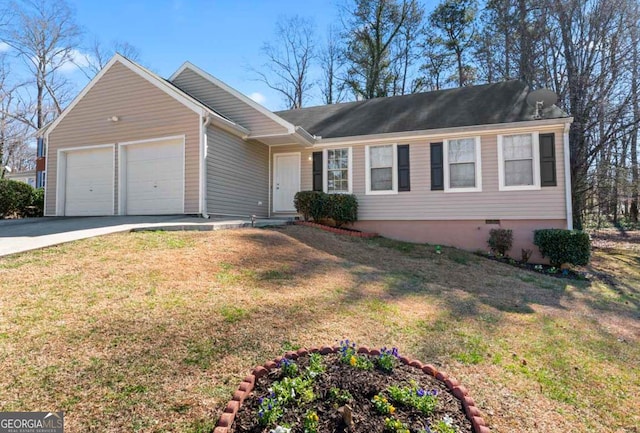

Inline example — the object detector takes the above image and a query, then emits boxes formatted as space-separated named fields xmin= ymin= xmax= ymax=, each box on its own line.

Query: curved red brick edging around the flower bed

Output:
xmin=213 ymin=346 xmax=490 ymax=433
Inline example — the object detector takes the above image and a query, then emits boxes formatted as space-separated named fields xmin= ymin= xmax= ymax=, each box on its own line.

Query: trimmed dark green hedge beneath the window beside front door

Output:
xmin=294 ymin=191 xmax=358 ymax=227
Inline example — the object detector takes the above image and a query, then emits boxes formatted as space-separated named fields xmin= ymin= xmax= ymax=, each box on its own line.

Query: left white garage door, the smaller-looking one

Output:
xmin=64 ymin=147 xmax=114 ymax=216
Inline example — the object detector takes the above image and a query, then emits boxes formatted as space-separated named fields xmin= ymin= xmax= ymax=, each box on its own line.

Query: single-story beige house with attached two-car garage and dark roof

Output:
xmin=41 ymin=55 xmax=572 ymax=255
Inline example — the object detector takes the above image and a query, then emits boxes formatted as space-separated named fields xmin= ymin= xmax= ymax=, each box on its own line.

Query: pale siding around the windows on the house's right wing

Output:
xmin=272 ymin=126 xmax=566 ymax=220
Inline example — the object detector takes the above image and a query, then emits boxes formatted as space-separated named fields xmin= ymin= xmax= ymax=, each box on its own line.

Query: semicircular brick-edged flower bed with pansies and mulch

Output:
xmin=214 ymin=340 xmax=489 ymax=433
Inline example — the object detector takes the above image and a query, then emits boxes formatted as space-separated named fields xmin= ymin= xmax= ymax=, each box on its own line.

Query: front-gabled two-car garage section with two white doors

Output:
xmin=44 ymin=55 xmax=204 ymax=216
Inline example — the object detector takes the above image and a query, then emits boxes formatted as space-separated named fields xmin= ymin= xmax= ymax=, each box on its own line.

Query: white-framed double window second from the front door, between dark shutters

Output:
xmin=365 ymin=144 xmax=398 ymax=194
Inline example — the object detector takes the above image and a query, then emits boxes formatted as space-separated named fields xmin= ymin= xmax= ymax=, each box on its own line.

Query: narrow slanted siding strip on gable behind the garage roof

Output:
xmin=173 ymin=68 xmax=287 ymax=135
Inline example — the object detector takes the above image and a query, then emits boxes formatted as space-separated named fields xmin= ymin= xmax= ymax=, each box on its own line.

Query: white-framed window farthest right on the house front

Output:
xmin=498 ymin=133 xmax=540 ymax=191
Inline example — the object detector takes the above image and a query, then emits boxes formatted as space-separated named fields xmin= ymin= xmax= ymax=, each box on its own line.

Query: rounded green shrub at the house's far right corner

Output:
xmin=533 ymin=229 xmax=591 ymax=267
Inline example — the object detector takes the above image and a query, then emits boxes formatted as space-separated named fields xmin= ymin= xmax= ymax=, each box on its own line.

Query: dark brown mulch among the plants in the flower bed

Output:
xmin=229 ymin=346 xmax=488 ymax=433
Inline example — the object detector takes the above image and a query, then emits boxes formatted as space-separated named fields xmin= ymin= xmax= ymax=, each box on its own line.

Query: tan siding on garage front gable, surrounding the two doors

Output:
xmin=45 ymin=62 xmax=201 ymax=215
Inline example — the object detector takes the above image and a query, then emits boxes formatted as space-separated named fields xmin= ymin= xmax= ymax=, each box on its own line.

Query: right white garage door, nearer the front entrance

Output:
xmin=120 ymin=139 xmax=184 ymax=215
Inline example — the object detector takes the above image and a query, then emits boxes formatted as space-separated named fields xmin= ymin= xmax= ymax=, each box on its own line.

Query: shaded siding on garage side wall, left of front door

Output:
xmin=207 ymin=128 xmax=269 ymax=217
